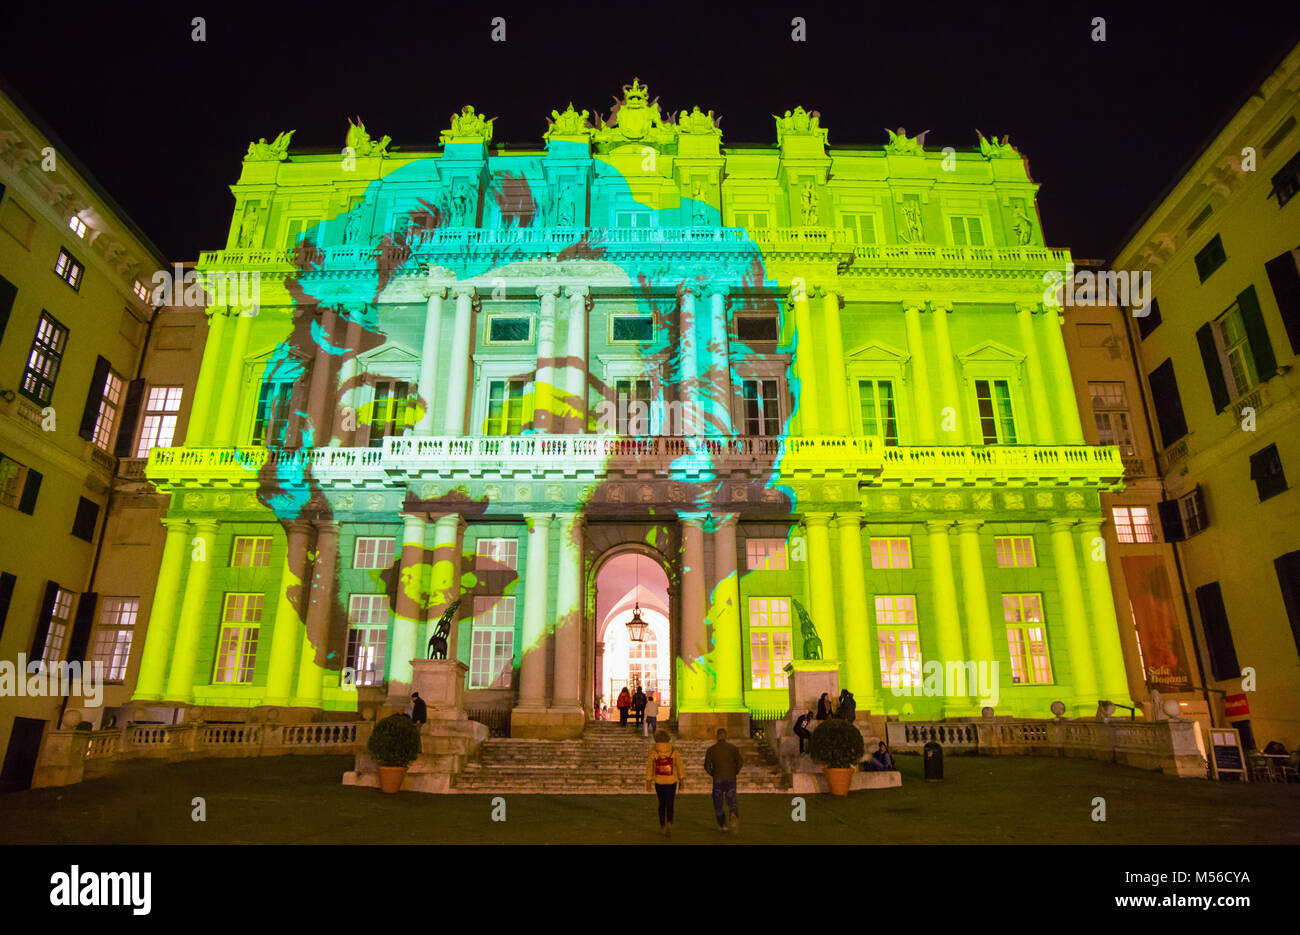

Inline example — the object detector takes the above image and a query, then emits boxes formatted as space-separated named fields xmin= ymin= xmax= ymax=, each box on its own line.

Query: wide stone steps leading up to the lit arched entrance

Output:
xmin=451 ymin=720 xmax=789 ymax=796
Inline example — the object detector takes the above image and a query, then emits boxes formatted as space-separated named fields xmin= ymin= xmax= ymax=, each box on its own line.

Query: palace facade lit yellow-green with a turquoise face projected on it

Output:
xmin=133 ymin=82 xmax=1141 ymax=737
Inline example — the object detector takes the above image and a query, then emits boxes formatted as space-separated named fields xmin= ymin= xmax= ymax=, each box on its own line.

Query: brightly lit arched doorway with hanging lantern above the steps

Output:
xmin=592 ymin=546 xmax=673 ymax=717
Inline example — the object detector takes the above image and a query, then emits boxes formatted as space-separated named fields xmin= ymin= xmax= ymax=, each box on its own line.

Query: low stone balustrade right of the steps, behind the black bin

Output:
xmin=885 ymin=718 xmax=1206 ymax=779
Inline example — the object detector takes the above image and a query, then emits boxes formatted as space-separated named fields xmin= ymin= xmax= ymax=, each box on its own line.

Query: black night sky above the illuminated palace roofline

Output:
xmin=0 ymin=0 xmax=1300 ymax=260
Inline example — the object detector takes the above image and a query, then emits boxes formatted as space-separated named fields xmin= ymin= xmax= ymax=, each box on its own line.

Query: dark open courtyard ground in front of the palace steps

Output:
xmin=0 ymin=757 xmax=1300 ymax=844
